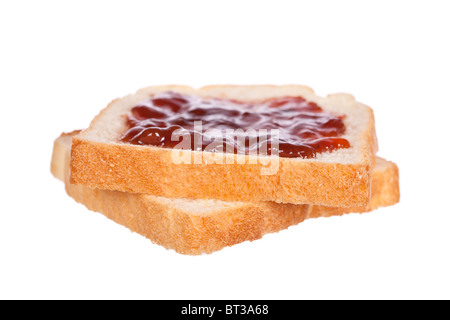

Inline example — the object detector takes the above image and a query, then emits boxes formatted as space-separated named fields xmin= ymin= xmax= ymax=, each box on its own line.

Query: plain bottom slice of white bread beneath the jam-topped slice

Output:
xmin=51 ymin=132 xmax=400 ymax=255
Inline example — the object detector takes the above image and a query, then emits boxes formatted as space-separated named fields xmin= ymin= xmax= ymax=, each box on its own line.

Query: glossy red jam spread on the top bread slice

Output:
xmin=120 ymin=92 xmax=350 ymax=158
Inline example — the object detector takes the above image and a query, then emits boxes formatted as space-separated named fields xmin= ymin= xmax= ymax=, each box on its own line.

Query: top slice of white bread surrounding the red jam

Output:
xmin=71 ymin=85 xmax=377 ymax=207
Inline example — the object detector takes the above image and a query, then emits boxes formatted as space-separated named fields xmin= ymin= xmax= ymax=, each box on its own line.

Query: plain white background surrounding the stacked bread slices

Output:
xmin=0 ymin=0 xmax=450 ymax=299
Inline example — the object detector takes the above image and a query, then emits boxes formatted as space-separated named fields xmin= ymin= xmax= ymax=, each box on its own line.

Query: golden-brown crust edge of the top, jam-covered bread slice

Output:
xmin=70 ymin=85 xmax=377 ymax=207
